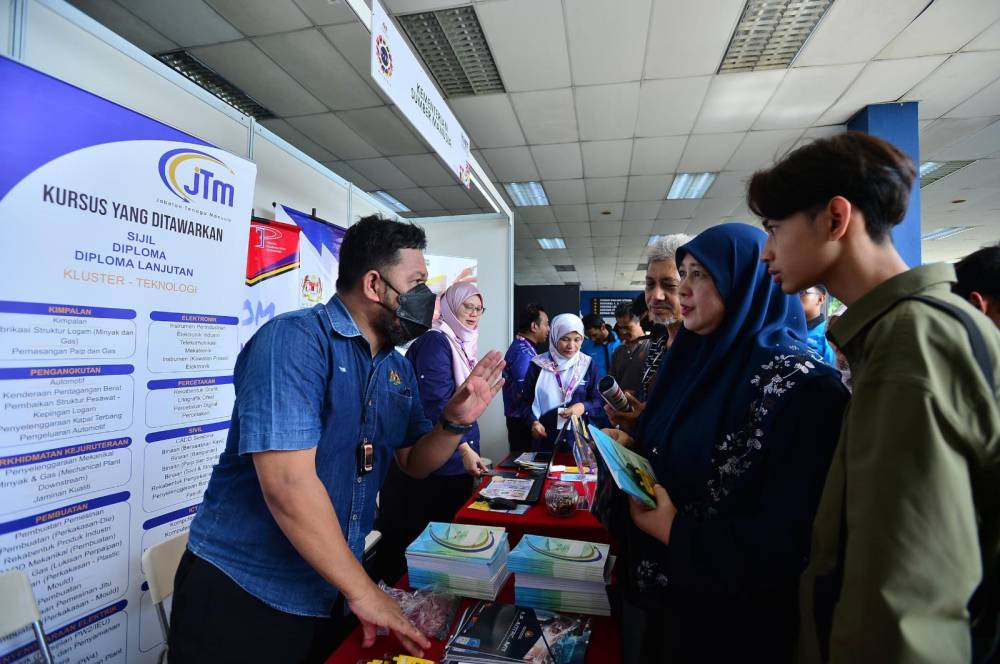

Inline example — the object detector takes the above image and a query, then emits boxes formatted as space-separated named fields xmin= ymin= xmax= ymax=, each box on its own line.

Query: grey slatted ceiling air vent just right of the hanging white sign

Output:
xmin=396 ymin=5 xmax=506 ymax=97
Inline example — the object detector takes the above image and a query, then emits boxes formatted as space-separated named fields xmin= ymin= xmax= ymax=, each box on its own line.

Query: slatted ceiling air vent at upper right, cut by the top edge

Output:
xmin=719 ymin=0 xmax=833 ymax=74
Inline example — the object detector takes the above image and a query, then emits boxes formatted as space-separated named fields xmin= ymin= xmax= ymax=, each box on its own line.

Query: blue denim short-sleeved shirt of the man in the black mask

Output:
xmin=188 ymin=296 xmax=433 ymax=617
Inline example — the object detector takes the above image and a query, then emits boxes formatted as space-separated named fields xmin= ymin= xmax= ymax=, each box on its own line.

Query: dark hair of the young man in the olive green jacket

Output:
xmin=747 ymin=131 xmax=917 ymax=243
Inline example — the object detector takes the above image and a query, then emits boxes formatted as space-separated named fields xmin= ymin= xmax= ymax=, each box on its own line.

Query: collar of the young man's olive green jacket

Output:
xmin=827 ymin=263 xmax=956 ymax=348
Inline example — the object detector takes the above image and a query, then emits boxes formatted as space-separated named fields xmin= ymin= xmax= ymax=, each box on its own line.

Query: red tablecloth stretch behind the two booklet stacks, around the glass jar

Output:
xmin=455 ymin=457 xmax=610 ymax=548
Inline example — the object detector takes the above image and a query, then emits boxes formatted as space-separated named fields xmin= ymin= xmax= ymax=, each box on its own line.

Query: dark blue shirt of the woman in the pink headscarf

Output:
xmin=406 ymin=330 xmax=479 ymax=475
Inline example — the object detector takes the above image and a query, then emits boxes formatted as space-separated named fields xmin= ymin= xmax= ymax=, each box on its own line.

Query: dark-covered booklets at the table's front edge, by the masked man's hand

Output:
xmin=441 ymin=602 xmax=590 ymax=664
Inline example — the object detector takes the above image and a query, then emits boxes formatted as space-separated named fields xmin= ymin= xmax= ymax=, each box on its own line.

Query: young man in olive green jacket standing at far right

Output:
xmin=748 ymin=132 xmax=1000 ymax=664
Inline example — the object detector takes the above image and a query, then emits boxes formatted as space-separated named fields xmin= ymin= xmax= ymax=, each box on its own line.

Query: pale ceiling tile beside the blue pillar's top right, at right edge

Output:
xmin=902 ymin=51 xmax=1000 ymax=118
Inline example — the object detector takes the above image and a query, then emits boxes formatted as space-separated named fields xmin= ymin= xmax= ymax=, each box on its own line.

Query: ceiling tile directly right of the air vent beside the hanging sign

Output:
xmin=476 ymin=0 xmax=575 ymax=92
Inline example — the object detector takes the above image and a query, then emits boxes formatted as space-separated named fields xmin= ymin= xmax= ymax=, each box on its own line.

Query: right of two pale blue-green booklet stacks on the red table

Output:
xmin=507 ymin=535 xmax=614 ymax=616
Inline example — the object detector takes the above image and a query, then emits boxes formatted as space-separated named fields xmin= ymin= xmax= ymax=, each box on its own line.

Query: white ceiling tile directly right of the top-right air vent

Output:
xmin=795 ymin=0 xmax=928 ymax=67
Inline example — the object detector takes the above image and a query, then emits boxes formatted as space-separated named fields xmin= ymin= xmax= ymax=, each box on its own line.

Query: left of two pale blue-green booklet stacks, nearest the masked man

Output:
xmin=406 ymin=521 xmax=510 ymax=600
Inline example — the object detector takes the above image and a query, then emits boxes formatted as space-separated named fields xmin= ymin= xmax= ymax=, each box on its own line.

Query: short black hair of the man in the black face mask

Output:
xmin=337 ymin=214 xmax=427 ymax=293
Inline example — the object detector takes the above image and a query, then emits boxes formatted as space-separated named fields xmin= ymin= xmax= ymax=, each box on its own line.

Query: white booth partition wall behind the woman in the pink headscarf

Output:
xmin=415 ymin=218 xmax=514 ymax=462
